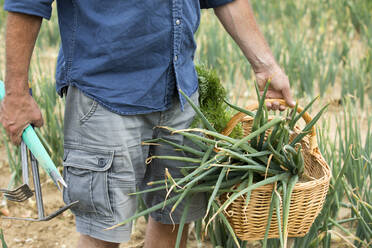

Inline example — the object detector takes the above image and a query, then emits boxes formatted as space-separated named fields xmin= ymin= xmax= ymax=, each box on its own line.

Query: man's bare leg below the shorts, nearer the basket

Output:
xmin=144 ymin=217 xmax=188 ymax=248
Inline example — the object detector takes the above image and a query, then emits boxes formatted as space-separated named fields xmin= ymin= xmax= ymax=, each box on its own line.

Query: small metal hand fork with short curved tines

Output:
xmin=0 ymin=141 xmax=34 ymax=202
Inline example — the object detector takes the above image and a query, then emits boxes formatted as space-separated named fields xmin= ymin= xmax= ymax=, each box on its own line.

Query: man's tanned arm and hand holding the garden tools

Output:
xmin=0 ymin=12 xmax=43 ymax=144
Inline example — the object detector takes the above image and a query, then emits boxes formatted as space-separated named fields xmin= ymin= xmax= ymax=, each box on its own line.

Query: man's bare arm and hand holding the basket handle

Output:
xmin=214 ymin=0 xmax=295 ymax=110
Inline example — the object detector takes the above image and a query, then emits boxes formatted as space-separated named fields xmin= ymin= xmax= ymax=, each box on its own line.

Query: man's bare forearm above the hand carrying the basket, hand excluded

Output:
xmin=215 ymin=0 xmax=275 ymax=72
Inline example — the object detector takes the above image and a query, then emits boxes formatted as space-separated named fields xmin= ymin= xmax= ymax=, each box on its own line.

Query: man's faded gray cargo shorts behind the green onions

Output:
xmin=63 ymin=86 xmax=205 ymax=243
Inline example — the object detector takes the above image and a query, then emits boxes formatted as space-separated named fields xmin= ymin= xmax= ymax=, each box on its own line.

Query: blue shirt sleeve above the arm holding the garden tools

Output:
xmin=4 ymin=0 xmax=53 ymax=20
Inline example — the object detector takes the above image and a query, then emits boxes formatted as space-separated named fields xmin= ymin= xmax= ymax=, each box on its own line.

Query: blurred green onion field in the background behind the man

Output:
xmin=0 ymin=0 xmax=372 ymax=248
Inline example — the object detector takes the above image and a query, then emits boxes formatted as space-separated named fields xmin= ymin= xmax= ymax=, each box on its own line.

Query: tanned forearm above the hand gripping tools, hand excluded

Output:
xmin=5 ymin=12 xmax=42 ymax=96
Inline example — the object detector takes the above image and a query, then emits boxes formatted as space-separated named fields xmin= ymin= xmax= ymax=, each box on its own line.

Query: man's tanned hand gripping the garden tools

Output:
xmin=0 ymin=89 xmax=43 ymax=145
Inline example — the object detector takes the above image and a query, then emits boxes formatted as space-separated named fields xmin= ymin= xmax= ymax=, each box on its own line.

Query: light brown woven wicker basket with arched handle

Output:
xmin=220 ymin=99 xmax=331 ymax=240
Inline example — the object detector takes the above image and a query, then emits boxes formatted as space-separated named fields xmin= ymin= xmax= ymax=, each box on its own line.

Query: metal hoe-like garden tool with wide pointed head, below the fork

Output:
xmin=3 ymin=147 xmax=78 ymax=221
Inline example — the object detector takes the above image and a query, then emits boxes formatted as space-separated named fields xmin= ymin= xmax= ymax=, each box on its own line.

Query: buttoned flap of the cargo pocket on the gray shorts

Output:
xmin=63 ymin=146 xmax=114 ymax=171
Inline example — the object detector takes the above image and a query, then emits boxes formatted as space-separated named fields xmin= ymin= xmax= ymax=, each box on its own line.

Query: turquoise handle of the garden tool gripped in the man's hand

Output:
xmin=0 ymin=81 xmax=67 ymax=190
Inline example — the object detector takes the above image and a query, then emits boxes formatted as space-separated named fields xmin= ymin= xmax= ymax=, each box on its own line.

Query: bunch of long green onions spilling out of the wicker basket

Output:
xmin=107 ymin=68 xmax=326 ymax=247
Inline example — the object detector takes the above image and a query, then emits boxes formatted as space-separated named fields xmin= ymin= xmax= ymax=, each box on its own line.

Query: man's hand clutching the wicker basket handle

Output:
xmin=256 ymin=64 xmax=296 ymax=111
